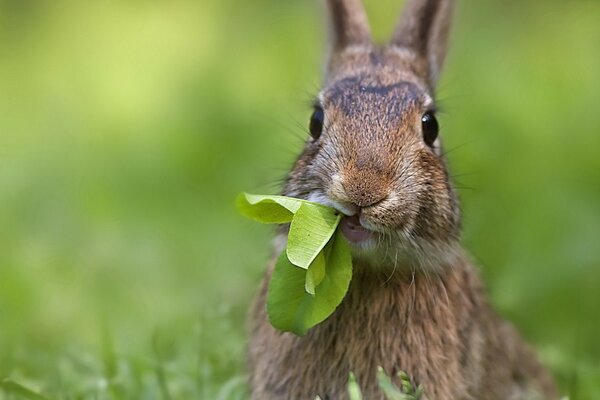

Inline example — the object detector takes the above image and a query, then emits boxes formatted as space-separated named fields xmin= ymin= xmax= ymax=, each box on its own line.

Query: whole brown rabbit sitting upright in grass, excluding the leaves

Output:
xmin=249 ymin=0 xmax=558 ymax=400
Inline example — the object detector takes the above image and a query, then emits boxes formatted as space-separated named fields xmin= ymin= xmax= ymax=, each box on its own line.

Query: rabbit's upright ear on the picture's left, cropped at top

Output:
xmin=327 ymin=0 xmax=371 ymax=74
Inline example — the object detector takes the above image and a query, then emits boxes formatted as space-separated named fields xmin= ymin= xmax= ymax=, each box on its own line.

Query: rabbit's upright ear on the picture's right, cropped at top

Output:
xmin=391 ymin=0 xmax=454 ymax=88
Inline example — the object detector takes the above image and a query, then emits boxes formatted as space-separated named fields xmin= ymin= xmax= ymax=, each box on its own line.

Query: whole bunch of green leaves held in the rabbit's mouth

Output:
xmin=236 ymin=193 xmax=352 ymax=335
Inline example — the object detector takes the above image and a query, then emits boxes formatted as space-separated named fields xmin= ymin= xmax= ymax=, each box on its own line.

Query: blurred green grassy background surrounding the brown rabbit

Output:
xmin=0 ymin=0 xmax=600 ymax=399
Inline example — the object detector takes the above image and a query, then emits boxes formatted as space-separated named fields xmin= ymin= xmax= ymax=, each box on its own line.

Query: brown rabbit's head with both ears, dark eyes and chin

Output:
xmin=284 ymin=0 xmax=460 ymax=269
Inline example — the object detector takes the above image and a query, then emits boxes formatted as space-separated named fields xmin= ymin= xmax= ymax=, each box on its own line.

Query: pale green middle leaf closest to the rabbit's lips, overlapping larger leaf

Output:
xmin=286 ymin=203 xmax=342 ymax=269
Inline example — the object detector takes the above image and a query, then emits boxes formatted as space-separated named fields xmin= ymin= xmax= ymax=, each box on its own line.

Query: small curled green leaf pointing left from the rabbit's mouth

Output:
xmin=236 ymin=193 xmax=305 ymax=224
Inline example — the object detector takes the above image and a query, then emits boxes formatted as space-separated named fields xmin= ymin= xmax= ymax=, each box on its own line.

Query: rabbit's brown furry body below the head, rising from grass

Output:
xmin=250 ymin=248 xmax=557 ymax=400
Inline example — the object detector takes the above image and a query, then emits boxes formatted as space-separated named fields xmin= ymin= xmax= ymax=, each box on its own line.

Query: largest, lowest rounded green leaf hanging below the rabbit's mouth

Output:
xmin=267 ymin=233 xmax=352 ymax=336
